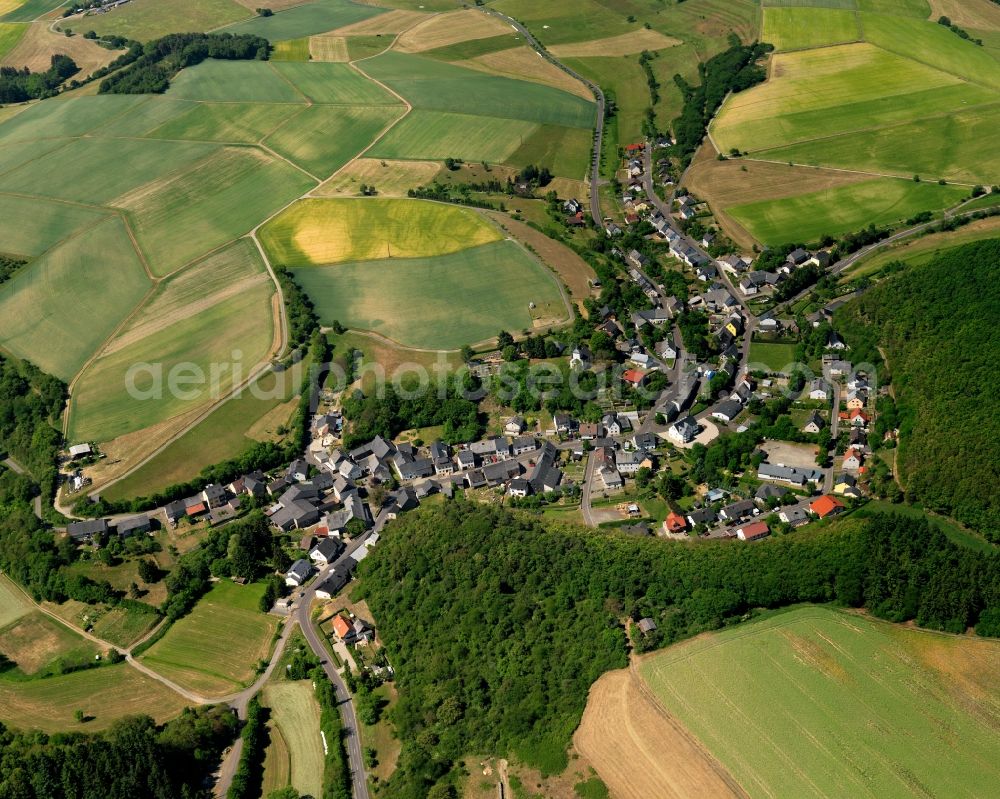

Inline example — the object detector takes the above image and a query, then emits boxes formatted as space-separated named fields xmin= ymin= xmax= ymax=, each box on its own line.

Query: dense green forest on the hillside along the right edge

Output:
xmin=836 ymin=239 xmax=1000 ymax=542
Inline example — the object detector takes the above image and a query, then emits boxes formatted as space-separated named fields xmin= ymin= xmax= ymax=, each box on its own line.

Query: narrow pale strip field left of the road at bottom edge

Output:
xmin=264 ymin=680 xmax=325 ymax=796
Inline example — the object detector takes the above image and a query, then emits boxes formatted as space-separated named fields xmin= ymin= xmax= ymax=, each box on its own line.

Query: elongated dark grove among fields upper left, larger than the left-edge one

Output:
xmin=93 ymin=33 xmax=270 ymax=94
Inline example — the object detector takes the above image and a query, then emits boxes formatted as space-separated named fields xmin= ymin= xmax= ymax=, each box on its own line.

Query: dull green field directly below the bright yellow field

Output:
xmin=295 ymin=241 xmax=567 ymax=349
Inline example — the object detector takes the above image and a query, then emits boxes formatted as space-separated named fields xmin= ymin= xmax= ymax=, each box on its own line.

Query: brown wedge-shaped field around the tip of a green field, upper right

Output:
xmin=684 ymin=139 xmax=871 ymax=249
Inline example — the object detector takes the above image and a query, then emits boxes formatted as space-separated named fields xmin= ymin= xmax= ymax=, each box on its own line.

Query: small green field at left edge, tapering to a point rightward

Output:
xmin=0 ymin=196 xmax=107 ymax=256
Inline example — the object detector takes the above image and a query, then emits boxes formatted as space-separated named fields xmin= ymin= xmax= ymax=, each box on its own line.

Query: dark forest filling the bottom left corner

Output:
xmin=0 ymin=707 xmax=238 ymax=799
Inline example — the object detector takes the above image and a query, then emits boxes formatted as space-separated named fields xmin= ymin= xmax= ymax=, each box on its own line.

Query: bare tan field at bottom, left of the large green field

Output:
xmin=573 ymin=669 xmax=746 ymax=799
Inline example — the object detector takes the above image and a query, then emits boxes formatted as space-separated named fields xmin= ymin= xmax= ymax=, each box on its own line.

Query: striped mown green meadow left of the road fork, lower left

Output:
xmin=140 ymin=580 xmax=278 ymax=697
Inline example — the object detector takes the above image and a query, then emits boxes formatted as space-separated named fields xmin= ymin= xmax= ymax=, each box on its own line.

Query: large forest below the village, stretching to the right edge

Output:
xmin=359 ymin=501 xmax=1000 ymax=799
